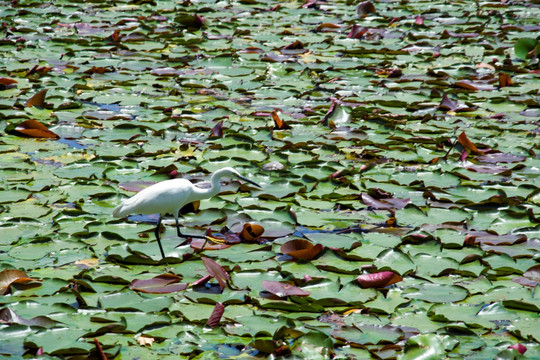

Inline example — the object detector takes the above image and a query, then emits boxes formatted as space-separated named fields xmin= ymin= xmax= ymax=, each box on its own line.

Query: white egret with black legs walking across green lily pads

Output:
xmin=113 ymin=167 xmax=261 ymax=258
